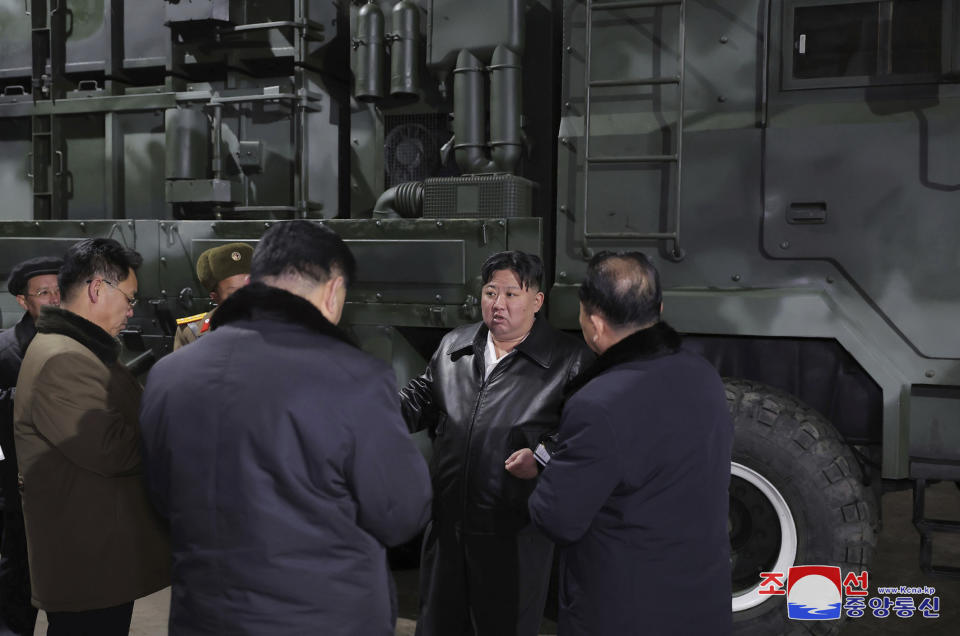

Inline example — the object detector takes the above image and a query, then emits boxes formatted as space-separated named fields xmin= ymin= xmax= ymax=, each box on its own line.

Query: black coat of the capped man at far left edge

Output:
xmin=0 ymin=314 xmax=37 ymax=514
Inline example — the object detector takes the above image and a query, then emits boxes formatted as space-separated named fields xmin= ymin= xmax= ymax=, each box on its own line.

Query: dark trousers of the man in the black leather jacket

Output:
xmin=416 ymin=521 xmax=553 ymax=636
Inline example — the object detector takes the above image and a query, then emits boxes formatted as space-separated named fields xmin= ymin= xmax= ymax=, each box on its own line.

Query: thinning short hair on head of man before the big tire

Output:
xmin=580 ymin=251 xmax=663 ymax=329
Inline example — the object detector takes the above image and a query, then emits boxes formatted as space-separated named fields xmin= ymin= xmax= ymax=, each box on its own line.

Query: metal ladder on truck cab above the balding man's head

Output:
xmin=583 ymin=0 xmax=686 ymax=260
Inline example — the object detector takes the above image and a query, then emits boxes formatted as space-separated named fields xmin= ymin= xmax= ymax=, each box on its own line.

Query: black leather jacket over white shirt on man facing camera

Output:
xmin=400 ymin=318 xmax=593 ymax=534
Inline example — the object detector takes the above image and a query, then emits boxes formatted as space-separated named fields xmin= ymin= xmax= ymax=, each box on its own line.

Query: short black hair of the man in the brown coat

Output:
xmin=57 ymin=239 xmax=143 ymax=300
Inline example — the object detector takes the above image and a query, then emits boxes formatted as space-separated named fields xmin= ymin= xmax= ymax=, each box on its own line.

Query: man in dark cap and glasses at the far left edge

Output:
xmin=0 ymin=256 xmax=63 ymax=634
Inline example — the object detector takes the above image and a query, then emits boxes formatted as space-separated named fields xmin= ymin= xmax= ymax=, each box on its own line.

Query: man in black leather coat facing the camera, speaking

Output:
xmin=402 ymin=251 xmax=593 ymax=636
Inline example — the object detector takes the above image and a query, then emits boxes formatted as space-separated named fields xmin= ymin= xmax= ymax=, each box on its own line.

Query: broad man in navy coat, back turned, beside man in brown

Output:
xmin=141 ymin=220 xmax=431 ymax=636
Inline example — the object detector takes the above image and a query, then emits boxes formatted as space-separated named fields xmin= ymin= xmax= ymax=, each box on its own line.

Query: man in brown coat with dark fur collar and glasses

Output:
xmin=14 ymin=239 xmax=170 ymax=636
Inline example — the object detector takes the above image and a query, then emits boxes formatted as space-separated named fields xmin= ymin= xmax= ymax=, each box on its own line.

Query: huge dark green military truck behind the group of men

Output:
xmin=0 ymin=0 xmax=960 ymax=635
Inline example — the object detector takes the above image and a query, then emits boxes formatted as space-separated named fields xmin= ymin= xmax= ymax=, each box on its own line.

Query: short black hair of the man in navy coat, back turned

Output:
xmin=250 ymin=220 xmax=357 ymax=287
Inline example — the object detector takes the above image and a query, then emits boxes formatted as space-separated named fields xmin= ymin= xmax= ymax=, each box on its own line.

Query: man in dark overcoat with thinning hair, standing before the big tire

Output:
xmin=530 ymin=252 xmax=733 ymax=636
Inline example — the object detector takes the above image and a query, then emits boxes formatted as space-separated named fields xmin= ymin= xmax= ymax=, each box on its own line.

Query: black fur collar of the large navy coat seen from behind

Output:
xmin=210 ymin=283 xmax=356 ymax=347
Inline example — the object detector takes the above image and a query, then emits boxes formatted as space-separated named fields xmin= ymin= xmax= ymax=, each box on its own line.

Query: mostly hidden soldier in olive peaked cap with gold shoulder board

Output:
xmin=173 ymin=243 xmax=253 ymax=351
